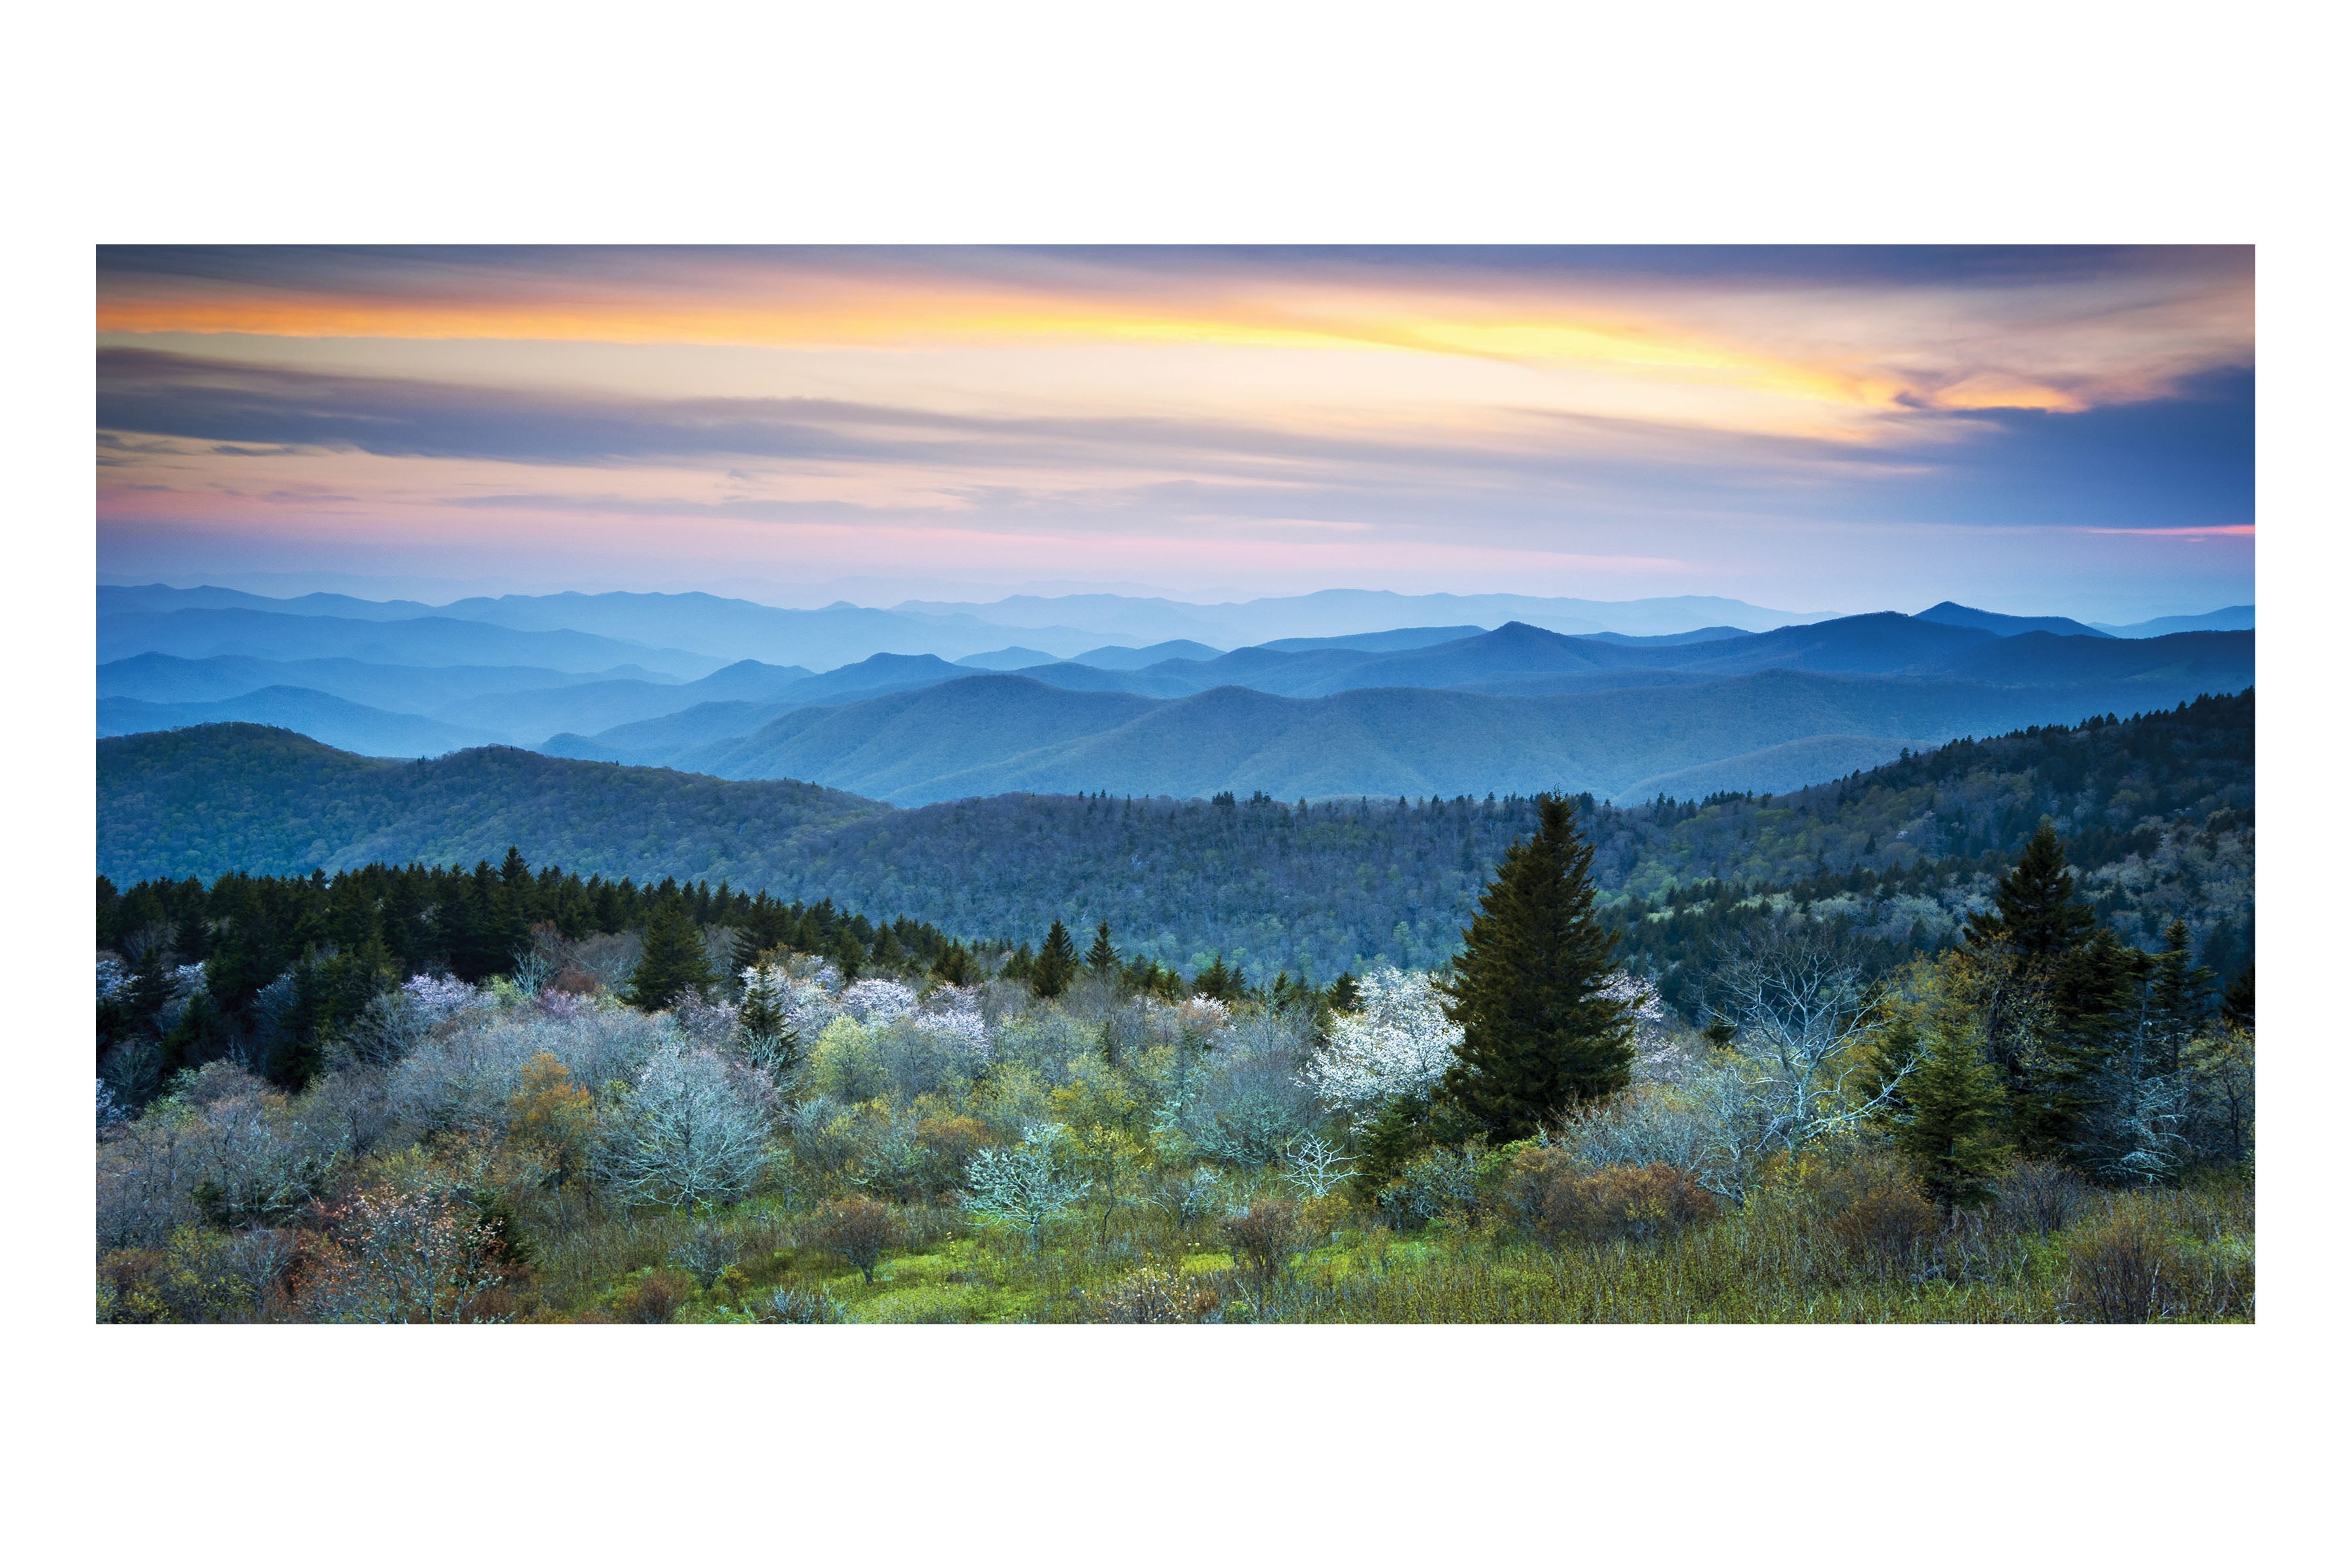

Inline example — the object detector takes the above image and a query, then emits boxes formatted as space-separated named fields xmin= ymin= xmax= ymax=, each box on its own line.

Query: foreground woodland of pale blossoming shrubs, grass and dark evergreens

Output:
xmin=97 ymin=761 xmax=2253 ymax=1324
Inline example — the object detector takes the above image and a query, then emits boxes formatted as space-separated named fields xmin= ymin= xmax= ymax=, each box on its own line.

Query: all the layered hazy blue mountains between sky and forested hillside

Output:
xmin=97 ymin=588 xmax=2253 ymax=804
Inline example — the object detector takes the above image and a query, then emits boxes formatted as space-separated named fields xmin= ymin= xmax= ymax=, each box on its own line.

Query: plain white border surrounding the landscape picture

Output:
xmin=0 ymin=0 xmax=2347 ymax=1563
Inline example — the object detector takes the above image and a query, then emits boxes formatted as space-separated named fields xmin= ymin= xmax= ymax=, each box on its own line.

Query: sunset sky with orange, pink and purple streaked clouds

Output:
xmin=97 ymin=247 xmax=2255 ymax=621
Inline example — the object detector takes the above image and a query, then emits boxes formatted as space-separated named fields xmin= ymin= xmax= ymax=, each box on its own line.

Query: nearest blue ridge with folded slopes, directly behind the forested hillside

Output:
xmin=635 ymin=670 xmax=2225 ymax=804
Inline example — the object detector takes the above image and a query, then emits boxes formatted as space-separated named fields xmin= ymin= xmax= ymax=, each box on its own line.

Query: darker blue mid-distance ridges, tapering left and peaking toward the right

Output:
xmin=544 ymin=613 xmax=2253 ymax=804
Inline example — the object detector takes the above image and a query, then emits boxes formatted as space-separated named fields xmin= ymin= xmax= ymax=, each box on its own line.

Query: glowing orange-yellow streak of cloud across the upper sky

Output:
xmin=99 ymin=263 xmax=2182 ymax=442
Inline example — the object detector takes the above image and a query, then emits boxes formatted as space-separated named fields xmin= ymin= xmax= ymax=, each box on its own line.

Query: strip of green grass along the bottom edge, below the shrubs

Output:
xmin=510 ymin=1178 xmax=2253 ymax=1324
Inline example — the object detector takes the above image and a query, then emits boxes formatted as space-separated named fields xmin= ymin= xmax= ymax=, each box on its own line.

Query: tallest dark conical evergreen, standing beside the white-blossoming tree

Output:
xmin=1437 ymin=794 xmax=1632 ymax=1143
